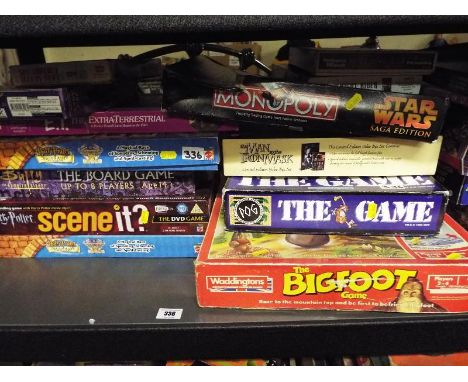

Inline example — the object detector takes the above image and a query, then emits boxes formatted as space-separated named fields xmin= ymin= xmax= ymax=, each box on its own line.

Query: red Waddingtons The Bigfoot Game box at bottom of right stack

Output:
xmin=195 ymin=198 xmax=468 ymax=313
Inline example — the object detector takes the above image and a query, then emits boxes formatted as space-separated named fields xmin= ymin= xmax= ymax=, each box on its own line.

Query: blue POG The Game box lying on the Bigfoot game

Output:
xmin=223 ymin=176 xmax=450 ymax=235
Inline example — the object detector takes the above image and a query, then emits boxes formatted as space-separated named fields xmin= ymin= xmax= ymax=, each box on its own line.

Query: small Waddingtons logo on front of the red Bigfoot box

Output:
xmin=206 ymin=276 xmax=273 ymax=293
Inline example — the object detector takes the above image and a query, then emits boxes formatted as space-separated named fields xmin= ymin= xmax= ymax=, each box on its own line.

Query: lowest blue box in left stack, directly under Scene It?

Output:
xmin=0 ymin=235 xmax=203 ymax=258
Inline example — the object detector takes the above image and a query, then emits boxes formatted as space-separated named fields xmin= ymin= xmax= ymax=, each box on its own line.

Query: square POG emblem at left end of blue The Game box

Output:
xmin=229 ymin=195 xmax=271 ymax=226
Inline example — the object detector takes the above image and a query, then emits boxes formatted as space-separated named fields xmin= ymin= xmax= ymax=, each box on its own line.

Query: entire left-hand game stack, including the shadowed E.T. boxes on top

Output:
xmin=0 ymin=58 xmax=229 ymax=258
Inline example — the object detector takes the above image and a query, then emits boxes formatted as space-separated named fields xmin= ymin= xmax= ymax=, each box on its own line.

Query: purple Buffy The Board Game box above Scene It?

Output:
xmin=0 ymin=169 xmax=210 ymax=201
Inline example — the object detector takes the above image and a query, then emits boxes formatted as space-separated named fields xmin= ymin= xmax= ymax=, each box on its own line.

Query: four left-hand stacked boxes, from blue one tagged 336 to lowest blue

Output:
xmin=0 ymin=135 xmax=219 ymax=257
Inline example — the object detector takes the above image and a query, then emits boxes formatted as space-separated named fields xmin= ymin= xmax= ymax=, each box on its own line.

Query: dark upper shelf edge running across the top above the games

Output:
xmin=0 ymin=15 xmax=468 ymax=48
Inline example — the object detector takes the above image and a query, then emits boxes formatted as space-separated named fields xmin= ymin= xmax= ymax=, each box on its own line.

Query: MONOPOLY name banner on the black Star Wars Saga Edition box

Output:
xmin=213 ymin=87 xmax=339 ymax=121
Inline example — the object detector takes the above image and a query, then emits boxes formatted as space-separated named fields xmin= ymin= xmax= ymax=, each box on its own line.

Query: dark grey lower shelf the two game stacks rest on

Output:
xmin=0 ymin=259 xmax=468 ymax=361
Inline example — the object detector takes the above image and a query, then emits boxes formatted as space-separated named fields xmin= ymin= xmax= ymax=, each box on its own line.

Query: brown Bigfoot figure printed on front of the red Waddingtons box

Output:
xmin=387 ymin=278 xmax=446 ymax=313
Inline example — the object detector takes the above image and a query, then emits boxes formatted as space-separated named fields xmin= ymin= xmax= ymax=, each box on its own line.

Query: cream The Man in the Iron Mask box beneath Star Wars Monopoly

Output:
xmin=223 ymin=137 xmax=442 ymax=177
